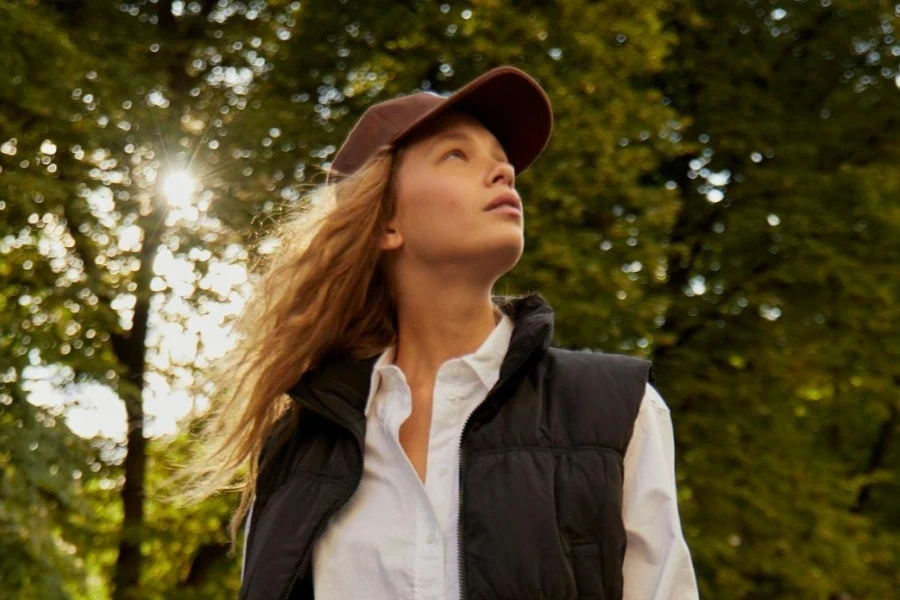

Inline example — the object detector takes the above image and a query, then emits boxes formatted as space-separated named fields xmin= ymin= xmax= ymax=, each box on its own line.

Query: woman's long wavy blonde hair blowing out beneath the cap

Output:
xmin=168 ymin=147 xmax=402 ymax=551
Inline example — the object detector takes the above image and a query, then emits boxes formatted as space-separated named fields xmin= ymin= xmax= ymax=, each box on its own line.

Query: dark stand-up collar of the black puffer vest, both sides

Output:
xmin=288 ymin=292 xmax=554 ymax=439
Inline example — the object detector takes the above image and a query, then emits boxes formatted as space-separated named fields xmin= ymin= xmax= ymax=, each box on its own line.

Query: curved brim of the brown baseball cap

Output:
xmin=391 ymin=66 xmax=553 ymax=173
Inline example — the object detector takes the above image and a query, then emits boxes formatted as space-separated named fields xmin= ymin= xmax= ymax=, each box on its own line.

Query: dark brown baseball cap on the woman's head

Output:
xmin=329 ymin=66 xmax=553 ymax=179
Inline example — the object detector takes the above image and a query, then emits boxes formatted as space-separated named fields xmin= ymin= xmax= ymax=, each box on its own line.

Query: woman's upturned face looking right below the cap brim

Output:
xmin=382 ymin=113 xmax=524 ymax=280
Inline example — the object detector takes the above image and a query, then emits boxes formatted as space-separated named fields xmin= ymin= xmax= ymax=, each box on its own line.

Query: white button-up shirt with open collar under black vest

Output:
xmin=247 ymin=314 xmax=698 ymax=600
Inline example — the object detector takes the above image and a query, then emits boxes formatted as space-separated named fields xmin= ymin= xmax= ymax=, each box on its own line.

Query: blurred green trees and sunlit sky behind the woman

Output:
xmin=0 ymin=0 xmax=900 ymax=600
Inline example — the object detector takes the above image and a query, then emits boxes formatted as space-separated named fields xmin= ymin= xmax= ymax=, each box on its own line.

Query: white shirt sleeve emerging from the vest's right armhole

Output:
xmin=622 ymin=383 xmax=699 ymax=600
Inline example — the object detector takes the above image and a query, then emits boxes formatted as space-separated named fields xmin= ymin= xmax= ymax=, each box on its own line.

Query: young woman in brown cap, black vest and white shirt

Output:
xmin=174 ymin=67 xmax=697 ymax=600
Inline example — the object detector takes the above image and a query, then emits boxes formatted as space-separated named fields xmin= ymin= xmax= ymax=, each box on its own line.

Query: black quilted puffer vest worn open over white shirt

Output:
xmin=240 ymin=294 xmax=653 ymax=600
